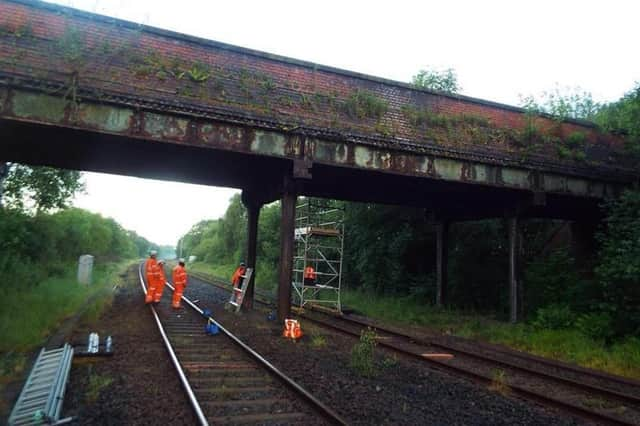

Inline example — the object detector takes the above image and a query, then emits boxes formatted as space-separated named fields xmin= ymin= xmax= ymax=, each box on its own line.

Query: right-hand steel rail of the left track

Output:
xmin=166 ymin=281 xmax=348 ymax=425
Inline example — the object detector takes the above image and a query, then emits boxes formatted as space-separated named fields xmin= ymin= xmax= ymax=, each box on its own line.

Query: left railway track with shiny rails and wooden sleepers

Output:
xmin=138 ymin=269 xmax=346 ymax=425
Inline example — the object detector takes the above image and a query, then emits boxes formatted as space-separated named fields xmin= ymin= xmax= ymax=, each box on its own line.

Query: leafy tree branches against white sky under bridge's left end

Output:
xmin=0 ymin=163 xmax=84 ymax=212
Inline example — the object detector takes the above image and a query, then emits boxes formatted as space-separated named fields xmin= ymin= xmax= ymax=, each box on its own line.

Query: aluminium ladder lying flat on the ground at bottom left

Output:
xmin=9 ymin=343 xmax=73 ymax=426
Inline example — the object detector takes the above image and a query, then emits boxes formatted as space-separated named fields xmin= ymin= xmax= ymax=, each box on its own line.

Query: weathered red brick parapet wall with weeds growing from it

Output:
xmin=0 ymin=0 xmax=624 ymax=176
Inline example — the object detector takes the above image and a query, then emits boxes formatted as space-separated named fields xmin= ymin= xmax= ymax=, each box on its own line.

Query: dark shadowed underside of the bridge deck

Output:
xmin=0 ymin=120 xmax=601 ymax=220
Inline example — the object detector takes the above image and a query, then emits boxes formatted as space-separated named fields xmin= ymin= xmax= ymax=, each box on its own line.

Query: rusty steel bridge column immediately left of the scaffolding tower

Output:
xmin=278 ymin=179 xmax=296 ymax=322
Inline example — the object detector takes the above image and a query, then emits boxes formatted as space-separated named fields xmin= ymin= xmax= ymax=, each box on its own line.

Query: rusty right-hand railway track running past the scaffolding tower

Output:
xmin=189 ymin=276 xmax=640 ymax=425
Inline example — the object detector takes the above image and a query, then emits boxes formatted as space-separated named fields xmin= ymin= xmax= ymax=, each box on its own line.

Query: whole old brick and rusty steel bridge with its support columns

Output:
xmin=0 ymin=0 xmax=638 ymax=321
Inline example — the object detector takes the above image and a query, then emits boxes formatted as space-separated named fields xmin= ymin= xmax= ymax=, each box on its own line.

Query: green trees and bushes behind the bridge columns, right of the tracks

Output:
xmin=183 ymin=188 xmax=640 ymax=377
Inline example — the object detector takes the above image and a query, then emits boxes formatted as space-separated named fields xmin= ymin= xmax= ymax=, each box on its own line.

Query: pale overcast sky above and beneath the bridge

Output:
xmin=60 ymin=0 xmax=640 ymax=244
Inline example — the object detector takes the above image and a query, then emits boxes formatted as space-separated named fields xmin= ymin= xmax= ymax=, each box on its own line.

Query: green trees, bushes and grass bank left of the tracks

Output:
xmin=0 ymin=164 xmax=160 ymax=392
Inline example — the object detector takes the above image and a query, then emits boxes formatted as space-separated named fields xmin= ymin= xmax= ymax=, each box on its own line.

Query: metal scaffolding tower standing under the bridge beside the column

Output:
xmin=293 ymin=198 xmax=344 ymax=312
